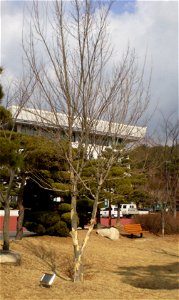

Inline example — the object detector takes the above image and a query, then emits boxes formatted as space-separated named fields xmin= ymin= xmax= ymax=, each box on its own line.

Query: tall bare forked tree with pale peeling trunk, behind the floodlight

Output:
xmin=23 ymin=0 xmax=149 ymax=281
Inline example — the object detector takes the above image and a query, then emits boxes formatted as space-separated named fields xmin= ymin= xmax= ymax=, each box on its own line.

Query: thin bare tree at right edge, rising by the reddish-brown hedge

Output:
xmin=142 ymin=113 xmax=179 ymax=236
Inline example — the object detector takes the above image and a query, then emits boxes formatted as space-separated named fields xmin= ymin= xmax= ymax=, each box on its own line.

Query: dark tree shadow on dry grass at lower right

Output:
xmin=117 ymin=262 xmax=179 ymax=290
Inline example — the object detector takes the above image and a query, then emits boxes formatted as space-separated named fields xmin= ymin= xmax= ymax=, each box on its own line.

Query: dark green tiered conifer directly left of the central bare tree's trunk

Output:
xmin=22 ymin=136 xmax=71 ymax=236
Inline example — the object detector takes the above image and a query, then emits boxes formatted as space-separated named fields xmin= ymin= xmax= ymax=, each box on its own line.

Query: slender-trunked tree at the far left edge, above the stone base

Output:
xmin=0 ymin=70 xmax=35 ymax=250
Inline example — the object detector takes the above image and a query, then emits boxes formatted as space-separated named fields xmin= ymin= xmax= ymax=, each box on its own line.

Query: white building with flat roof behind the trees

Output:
xmin=8 ymin=106 xmax=146 ymax=158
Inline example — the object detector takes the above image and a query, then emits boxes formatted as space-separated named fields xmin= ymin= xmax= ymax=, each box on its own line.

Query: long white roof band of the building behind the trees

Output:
xmin=8 ymin=106 xmax=147 ymax=140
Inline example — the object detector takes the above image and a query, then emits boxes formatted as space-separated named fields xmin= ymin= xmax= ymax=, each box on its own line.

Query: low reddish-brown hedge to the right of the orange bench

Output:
xmin=134 ymin=213 xmax=179 ymax=234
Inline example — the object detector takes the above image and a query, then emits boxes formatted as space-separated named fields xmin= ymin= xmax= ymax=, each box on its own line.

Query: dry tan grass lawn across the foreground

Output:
xmin=0 ymin=231 xmax=179 ymax=300
